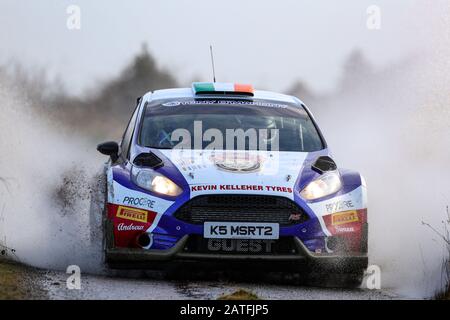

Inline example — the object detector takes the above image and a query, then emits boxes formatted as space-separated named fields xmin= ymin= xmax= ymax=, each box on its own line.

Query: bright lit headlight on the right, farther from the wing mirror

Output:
xmin=300 ymin=171 xmax=342 ymax=200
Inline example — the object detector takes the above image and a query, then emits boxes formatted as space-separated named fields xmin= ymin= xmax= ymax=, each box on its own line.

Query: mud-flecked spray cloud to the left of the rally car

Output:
xmin=0 ymin=82 xmax=106 ymax=272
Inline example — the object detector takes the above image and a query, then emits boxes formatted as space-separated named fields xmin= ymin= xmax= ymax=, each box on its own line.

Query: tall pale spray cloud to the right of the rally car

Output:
xmin=311 ymin=2 xmax=450 ymax=297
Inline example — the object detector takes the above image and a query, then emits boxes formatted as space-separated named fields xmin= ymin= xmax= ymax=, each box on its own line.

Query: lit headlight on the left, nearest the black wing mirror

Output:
xmin=131 ymin=166 xmax=183 ymax=197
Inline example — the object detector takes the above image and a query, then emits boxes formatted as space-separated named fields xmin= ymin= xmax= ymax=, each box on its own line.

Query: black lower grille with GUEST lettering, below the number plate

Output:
xmin=184 ymin=235 xmax=297 ymax=255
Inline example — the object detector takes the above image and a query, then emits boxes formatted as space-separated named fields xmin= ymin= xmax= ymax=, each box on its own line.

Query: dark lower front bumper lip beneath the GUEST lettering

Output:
xmin=106 ymin=235 xmax=368 ymax=272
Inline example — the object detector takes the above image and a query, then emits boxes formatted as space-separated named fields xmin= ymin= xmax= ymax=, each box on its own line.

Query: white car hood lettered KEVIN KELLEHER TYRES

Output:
xmin=160 ymin=150 xmax=308 ymax=198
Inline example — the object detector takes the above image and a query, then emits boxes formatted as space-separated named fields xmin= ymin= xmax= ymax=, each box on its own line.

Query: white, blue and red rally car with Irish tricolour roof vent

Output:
xmin=97 ymin=83 xmax=368 ymax=284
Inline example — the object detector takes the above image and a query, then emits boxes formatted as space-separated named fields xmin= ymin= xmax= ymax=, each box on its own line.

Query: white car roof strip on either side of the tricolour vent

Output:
xmin=142 ymin=88 xmax=303 ymax=104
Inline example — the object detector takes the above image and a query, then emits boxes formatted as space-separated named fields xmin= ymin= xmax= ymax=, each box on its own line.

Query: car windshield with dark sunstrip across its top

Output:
xmin=139 ymin=99 xmax=324 ymax=152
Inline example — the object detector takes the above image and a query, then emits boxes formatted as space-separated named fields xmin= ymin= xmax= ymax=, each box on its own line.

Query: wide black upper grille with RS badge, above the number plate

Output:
xmin=174 ymin=195 xmax=308 ymax=226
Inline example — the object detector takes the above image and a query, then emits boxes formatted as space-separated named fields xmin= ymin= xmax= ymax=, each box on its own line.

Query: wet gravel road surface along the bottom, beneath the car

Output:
xmin=37 ymin=271 xmax=402 ymax=300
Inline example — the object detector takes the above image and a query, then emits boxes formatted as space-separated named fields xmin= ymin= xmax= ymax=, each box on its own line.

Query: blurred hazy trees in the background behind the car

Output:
xmin=0 ymin=44 xmax=376 ymax=141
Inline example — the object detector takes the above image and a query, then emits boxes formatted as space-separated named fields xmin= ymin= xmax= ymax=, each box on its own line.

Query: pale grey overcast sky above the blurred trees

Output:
xmin=0 ymin=0 xmax=432 ymax=92
